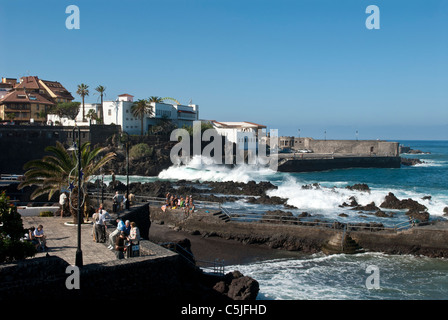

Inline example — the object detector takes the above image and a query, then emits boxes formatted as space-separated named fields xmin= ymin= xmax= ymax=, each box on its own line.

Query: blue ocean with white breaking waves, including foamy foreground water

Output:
xmin=113 ymin=141 xmax=448 ymax=300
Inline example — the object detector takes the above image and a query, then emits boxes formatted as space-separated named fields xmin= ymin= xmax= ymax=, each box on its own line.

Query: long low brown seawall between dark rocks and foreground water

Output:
xmin=150 ymin=207 xmax=448 ymax=257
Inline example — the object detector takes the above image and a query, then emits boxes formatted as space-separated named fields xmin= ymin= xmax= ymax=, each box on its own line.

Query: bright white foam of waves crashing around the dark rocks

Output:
xmin=158 ymin=156 xmax=448 ymax=218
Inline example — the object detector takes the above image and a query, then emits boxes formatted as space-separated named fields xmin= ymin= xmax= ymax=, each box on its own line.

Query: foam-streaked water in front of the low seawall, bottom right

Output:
xmin=226 ymin=253 xmax=448 ymax=300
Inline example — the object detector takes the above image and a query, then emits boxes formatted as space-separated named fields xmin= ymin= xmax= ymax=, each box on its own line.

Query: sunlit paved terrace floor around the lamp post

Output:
xmin=22 ymin=217 xmax=117 ymax=265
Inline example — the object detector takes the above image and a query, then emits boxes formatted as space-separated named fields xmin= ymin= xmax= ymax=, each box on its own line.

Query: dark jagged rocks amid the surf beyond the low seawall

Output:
xmin=106 ymin=180 xmax=448 ymax=223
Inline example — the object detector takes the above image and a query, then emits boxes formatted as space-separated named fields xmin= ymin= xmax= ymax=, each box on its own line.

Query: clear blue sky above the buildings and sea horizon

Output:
xmin=0 ymin=0 xmax=448 ymax=140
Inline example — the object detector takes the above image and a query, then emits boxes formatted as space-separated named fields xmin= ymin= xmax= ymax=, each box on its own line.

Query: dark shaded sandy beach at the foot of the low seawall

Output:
xmin=149 ymin=223 xmax=303 ymax=265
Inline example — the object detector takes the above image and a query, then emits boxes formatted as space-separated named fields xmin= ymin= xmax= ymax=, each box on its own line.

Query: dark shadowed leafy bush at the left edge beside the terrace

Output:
xmin=0 ymin=191 xmax=36 ymax=263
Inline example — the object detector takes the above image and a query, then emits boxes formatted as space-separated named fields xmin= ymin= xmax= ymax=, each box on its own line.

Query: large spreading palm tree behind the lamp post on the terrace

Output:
xmin=18 ymin=141 xmax=115 ymax=221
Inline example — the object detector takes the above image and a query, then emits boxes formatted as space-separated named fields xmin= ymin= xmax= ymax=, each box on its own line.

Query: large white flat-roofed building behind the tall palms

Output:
xmin=103 ymin=94 xmax=199 ymax=134
